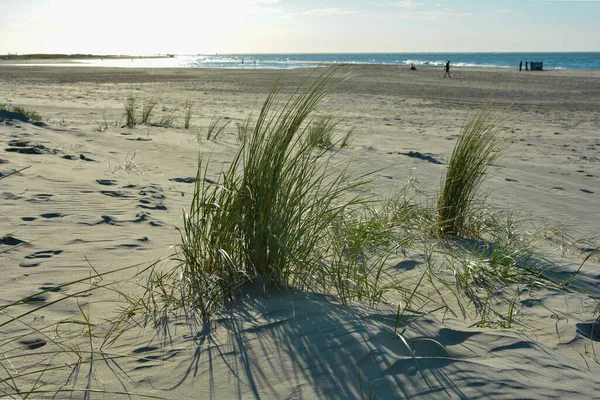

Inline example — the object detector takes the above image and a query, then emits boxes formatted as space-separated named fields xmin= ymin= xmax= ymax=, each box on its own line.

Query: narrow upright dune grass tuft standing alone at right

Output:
xmin=437 ymin=107 xmax=507 ymax=237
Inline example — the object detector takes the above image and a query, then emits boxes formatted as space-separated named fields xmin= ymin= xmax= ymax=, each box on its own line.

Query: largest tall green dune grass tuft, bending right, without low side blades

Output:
xmin=180 ymin=69 xmax=366 ymax=312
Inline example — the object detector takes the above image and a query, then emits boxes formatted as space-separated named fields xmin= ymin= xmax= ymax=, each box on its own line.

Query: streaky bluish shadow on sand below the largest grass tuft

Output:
xmin=158 ymin=289 xmax=466 ymax=399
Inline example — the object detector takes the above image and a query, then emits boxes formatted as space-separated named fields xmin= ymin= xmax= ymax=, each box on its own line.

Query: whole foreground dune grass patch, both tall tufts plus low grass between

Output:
xmin=122 ymin=70 xmax=596 ymax=327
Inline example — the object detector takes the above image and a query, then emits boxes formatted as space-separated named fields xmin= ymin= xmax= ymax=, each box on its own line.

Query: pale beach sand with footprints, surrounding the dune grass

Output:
xmin=0 ymin=61 xmax=600 ymax=399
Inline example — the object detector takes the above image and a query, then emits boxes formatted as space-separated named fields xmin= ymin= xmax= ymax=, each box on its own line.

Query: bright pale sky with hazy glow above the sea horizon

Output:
xmin=0 ymin=0 xmax=600 ymax=55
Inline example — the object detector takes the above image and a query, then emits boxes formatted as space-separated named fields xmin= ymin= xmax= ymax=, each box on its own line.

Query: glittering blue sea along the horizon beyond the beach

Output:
xmin=25 ymin=52 xmax=600 ymax=70
